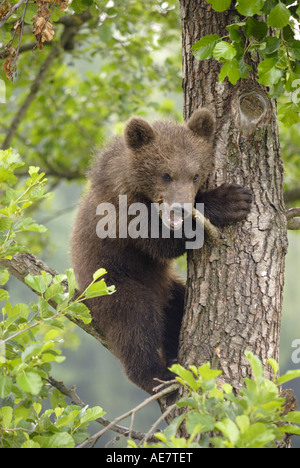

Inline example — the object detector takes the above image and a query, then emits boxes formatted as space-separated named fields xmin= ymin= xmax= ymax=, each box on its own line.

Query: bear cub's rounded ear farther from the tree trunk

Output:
xmin=124 ymin=117 xmax=155 ymax=149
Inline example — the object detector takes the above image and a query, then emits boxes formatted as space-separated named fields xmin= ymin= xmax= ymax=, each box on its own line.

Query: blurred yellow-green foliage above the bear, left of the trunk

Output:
xmin=0 ymin=0 xmax=181 ymax=176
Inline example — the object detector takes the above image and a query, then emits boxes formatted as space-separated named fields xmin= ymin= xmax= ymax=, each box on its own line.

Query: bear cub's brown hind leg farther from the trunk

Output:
xmin=100 ymin=281 xmax=173 ymax=394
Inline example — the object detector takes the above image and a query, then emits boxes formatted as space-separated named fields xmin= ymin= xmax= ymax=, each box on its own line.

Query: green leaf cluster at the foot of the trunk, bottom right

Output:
xmin=129 ymin=351 xmax=300 ymax=448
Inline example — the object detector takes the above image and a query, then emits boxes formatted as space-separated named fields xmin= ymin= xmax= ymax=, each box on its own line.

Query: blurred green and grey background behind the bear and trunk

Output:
xmin=0 ymin=0 xmax=300 ymax=447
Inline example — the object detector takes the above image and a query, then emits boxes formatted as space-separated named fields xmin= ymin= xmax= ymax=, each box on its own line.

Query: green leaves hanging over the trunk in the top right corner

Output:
xmin=192 ymin=0 xmax=300 ymax=126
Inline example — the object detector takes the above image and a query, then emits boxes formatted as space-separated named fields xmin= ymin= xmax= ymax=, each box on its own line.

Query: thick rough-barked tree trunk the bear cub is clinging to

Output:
xmin=161 ymin=0 xmax=287 ymax=412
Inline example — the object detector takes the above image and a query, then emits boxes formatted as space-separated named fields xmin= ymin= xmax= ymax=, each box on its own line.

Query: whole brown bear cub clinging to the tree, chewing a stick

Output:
xmin=71 ymin=109 xmax=251 ymax=393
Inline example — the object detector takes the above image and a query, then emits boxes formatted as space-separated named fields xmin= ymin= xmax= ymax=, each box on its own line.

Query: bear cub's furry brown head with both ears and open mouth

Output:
xmin=124 ymin=109 xmax=215 ymax=229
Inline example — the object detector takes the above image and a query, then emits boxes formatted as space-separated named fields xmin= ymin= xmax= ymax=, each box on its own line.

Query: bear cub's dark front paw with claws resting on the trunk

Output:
xmin=196 ymin=184 xmax=252 ymax=226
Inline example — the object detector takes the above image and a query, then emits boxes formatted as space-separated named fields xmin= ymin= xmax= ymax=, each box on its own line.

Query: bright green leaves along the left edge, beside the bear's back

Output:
xmin=0 ymin=150 xmax=114 ymax=448
